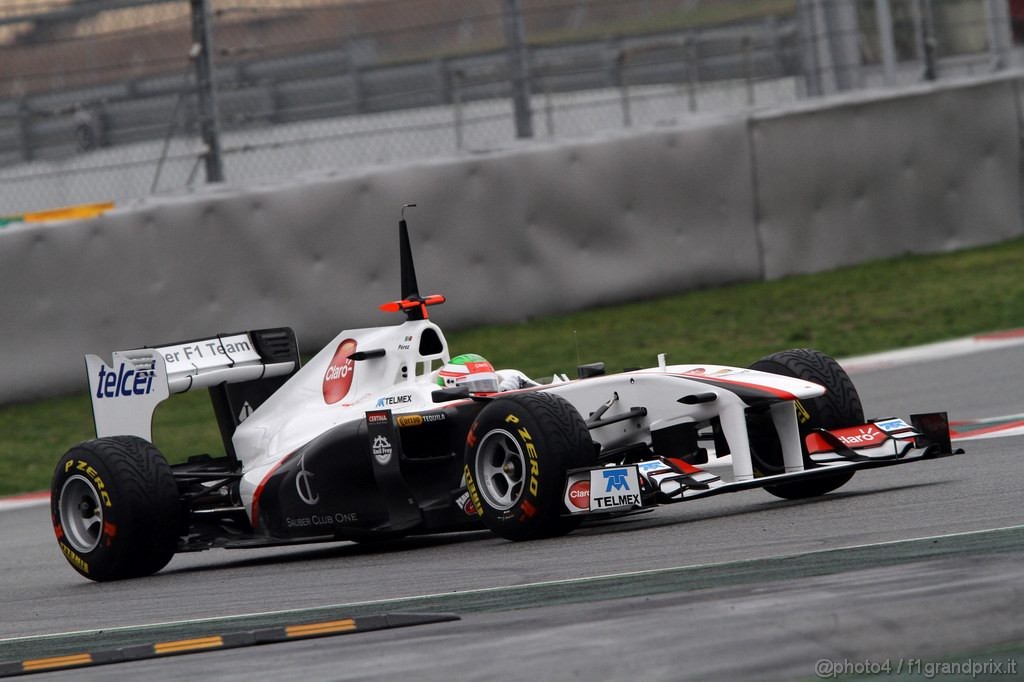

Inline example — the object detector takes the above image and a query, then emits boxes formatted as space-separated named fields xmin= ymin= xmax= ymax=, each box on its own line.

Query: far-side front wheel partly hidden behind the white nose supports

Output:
xmin=748 ymin=348 xmax=864 ymax=500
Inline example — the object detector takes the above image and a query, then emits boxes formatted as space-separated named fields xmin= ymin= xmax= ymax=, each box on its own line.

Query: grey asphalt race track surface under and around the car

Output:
xmin=0 ymin=347 xmax=1024 ymax=680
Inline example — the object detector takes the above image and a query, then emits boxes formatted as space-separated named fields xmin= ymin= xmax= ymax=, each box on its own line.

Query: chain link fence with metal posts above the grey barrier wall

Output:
xmin=0 ymin=0 xmax=1024 ymax=215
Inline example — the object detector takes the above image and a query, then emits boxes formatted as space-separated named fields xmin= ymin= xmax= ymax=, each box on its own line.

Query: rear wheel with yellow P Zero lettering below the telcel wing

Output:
xmin=50 ymin=436 xmax=180 ymax=582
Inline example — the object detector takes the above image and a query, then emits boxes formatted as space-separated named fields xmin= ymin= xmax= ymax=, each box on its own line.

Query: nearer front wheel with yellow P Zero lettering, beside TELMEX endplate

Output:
xmin=465 ymin=392 xmax=596 ymax=541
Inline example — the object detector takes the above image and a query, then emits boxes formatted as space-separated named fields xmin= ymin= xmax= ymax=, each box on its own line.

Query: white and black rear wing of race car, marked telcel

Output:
xmin=85 ymin=328 xmax=299 ymax=448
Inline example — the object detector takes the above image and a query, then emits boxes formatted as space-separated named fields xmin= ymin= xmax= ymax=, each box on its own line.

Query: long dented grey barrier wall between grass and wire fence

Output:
xmin=0 ymin=78 xmax=1024 ymax=402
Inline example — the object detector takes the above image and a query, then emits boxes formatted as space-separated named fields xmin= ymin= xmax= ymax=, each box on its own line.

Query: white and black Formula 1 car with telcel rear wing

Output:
xmin=51 ymin=208 xmax=954 ymax=581
